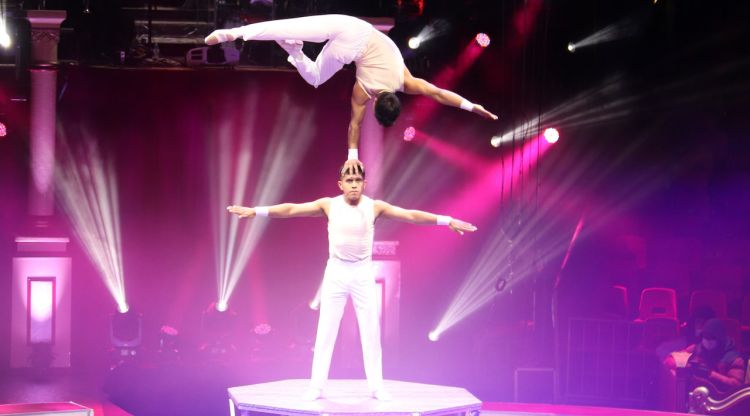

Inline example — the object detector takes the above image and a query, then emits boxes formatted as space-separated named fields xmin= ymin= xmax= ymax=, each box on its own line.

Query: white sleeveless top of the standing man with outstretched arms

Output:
xmin=328 ymin=195 xmax=375 ymax=262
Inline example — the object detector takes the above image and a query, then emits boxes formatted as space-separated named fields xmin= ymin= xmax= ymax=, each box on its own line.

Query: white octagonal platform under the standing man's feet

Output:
xmin=228 ymin=380 xmax=482 ymax=416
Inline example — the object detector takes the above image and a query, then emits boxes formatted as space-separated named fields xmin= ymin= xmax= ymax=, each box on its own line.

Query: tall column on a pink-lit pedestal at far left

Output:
xmin=10 ymin=10 xmax=72 ymax=369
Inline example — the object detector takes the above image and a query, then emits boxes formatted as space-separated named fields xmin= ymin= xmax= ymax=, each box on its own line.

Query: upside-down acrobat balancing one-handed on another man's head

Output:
xmin=205 ymin=14 xmax=497 ymax=167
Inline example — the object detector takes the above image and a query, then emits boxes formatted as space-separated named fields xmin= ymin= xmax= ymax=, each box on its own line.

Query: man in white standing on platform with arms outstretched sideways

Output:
xmin=227 ymin=167 xmax=477 ymax=401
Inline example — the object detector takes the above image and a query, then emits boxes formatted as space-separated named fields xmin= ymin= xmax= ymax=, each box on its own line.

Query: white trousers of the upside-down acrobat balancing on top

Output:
xmin=229 ymin=14 xmax=374 ymax=87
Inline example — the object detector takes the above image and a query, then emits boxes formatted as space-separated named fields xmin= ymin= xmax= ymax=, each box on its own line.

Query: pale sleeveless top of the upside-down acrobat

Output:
xmin=354 ymin=27 xmax=406 ymax=98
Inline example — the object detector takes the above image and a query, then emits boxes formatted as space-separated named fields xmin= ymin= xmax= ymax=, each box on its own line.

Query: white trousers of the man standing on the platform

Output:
xmin=310 ymin=259 xmax=383 ymax=391
